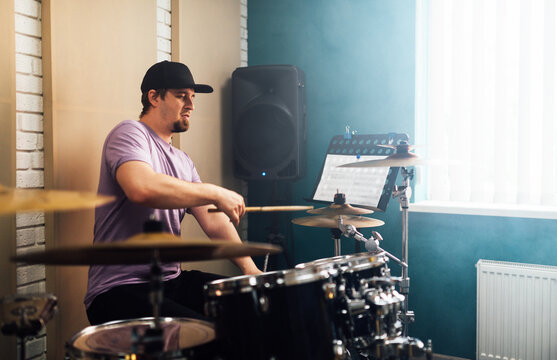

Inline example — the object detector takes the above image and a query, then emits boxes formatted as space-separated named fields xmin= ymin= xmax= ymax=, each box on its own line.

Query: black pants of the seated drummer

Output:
xmin=87 ymin=270 xmax=223 ymax=325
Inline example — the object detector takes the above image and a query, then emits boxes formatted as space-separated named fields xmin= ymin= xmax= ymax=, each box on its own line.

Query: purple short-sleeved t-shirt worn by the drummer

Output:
xmin=84 ymin=120 xmax=201 ymax=307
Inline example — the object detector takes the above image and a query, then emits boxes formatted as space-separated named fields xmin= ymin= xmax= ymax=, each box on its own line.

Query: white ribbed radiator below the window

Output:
xmin=476 ymin=254 xmax=557 ymax=360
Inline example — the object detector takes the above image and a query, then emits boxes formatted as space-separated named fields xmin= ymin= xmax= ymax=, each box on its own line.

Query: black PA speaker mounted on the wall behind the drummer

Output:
xmin=232 ymin=65 xmax=306 ymax=180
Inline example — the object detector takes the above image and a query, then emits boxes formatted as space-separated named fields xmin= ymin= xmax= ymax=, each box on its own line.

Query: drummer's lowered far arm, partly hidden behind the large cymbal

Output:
xmin=190 ymin=205 xmax=261 ymax=275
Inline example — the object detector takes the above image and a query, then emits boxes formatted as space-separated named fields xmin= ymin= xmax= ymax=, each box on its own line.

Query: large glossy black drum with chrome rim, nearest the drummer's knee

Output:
xmin=205 ymin=269 xmax=343 ymax=360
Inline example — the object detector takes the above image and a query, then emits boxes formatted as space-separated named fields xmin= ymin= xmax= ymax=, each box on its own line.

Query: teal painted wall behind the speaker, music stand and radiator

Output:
xmin=248 ymin=0 xmax=557 ymax=359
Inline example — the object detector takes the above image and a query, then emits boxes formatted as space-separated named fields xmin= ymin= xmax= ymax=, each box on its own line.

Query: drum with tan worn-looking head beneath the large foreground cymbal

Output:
xmin=66 ymin=318 xmax=215 ymax=360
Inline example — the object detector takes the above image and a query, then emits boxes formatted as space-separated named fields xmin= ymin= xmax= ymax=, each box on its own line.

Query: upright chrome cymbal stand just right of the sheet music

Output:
xmin=392 ymin=167 xmax=414 ymax=336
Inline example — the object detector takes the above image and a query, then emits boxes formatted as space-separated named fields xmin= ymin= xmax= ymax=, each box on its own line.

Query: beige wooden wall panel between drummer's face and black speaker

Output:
xmin=177 ymin=0 xmax=241 ymax=275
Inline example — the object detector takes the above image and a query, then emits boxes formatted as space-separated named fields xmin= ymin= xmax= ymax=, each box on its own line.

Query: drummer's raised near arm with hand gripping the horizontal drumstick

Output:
xmin=116 ymin=161 xmax=245 ymax=225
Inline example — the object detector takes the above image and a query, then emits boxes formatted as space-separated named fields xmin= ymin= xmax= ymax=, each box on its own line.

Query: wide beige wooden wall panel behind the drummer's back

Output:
xmin=43 ymin=0 xmax=157 ymax=359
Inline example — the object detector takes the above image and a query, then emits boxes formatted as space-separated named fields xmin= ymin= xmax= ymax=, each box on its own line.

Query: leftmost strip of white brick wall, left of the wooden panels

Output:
xmin=14 ymin=0 xmax=46 ymax=360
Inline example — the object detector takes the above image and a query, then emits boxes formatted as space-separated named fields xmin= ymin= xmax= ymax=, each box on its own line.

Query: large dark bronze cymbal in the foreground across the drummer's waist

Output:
xmin=11 ymin=233 xmax=282 ymax=265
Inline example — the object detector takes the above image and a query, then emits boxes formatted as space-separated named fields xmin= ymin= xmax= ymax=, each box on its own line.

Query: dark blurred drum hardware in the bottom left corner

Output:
xmin=0 ymin=294 xmax=58 ymax=359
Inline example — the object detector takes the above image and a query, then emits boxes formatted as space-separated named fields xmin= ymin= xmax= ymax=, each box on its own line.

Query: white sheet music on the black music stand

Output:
xmin=313 ymin=154 xmax=390 ymax=207
